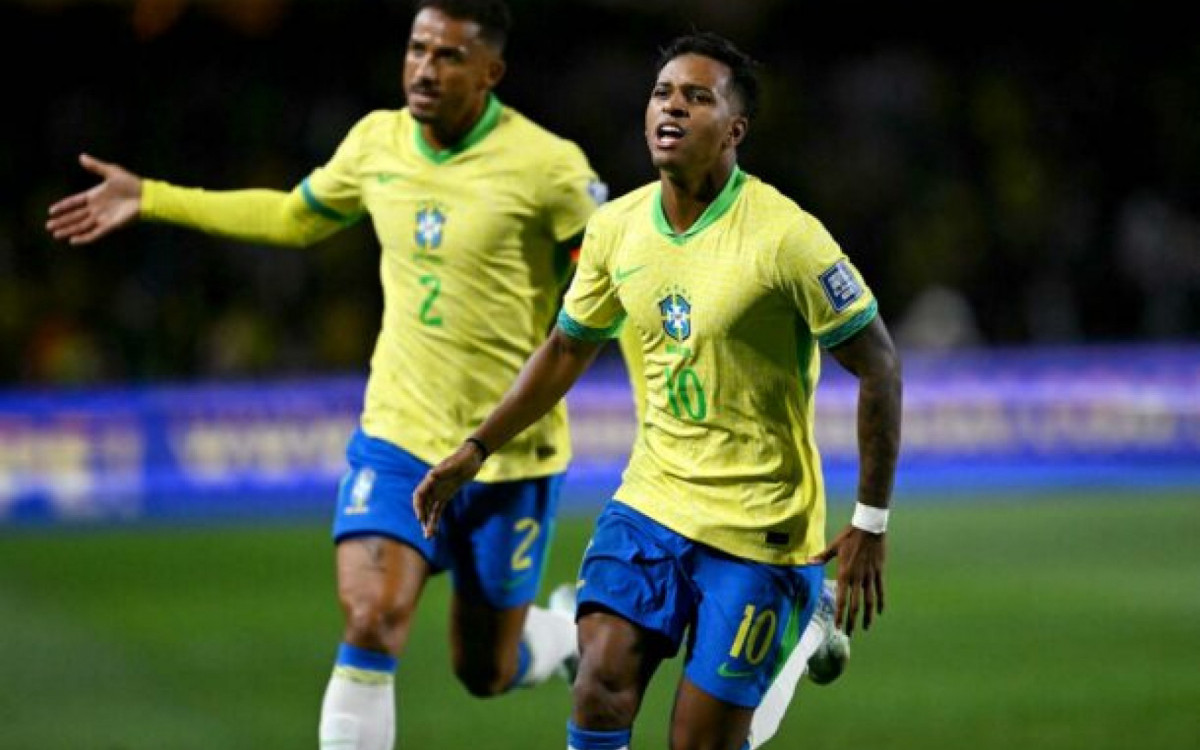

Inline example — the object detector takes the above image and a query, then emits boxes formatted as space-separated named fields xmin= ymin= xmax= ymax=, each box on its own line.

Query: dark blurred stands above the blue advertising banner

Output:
xmin=0 ymin=0 xmax=1200 ymax=385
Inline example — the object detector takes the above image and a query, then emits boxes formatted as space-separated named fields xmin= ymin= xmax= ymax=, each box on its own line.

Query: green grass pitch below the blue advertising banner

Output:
xmin=0 ymin=492 xmax=1200 ymax=750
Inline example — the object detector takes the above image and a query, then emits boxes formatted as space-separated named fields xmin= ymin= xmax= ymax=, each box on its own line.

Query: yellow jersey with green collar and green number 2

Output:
xmin=300 ymin=97 xmax=602 ymax=481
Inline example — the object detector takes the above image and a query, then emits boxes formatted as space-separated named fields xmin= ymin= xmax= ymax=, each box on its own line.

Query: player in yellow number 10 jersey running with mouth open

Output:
xmin=413 ymin=34 xmax=901 ymax=750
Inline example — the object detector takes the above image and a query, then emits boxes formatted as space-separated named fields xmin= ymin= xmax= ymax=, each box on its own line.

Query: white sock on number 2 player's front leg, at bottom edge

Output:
xmin=320 ymin=666 xmax=396 ymax=750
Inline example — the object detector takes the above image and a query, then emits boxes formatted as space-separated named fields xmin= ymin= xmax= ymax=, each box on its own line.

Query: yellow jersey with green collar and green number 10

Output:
xmin=558 ymin=169 xmax=876 ymax=565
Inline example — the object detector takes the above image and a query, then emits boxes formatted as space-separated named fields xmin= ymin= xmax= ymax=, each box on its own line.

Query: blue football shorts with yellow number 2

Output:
xmin=334 ymin=430 xmax=563 ymax=608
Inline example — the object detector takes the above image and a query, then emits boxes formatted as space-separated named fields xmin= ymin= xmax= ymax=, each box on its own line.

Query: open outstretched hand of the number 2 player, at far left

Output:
xmin=46 ymin=154 xmax=142 ymax=245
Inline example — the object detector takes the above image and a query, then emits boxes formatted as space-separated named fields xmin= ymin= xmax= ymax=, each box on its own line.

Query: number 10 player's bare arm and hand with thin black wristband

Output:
xmin=413 ymin=328 xmax=602 ymax=536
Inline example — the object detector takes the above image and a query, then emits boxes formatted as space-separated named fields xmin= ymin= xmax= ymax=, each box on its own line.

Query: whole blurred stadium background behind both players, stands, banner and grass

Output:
xmin=0 ymin=0 xmax=1200 ymax=749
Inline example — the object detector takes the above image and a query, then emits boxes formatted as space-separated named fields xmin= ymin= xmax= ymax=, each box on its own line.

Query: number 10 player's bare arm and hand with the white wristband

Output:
xmin=815 ymin=317 xmax=902 ymax=634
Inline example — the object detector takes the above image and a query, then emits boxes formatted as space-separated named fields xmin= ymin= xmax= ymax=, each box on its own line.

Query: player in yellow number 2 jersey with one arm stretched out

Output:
xmin=47 ymin=0 xmax=602 ymax=750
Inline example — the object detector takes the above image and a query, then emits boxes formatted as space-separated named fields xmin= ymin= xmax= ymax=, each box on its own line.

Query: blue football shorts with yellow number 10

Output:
xmin=578 ymin=500 xmax=824 ymax=708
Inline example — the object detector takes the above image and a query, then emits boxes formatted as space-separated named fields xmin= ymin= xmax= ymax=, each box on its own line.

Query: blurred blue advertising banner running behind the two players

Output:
xmin=0 ymin=347 xmax=1200 ymax=522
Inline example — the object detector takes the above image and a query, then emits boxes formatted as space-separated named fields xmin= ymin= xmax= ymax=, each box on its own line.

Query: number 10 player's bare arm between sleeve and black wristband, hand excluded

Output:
xmin=472 ymin=329 xmax=600 ymax=451
